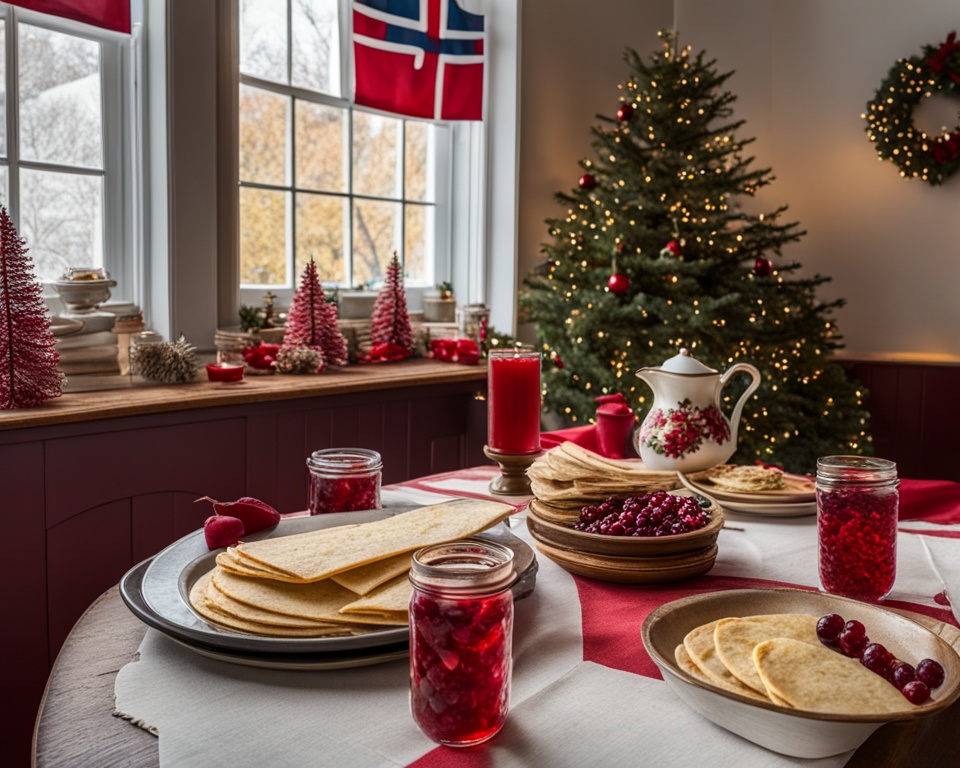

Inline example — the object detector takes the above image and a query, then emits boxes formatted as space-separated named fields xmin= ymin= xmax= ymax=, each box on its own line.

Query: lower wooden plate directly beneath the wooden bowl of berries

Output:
xmin=530 ymin=529 xmax=718 ymax=584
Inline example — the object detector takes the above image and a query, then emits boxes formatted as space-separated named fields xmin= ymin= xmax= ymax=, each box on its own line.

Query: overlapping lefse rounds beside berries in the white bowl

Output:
xmin=675 ymin=614 xmax=911 ymax=715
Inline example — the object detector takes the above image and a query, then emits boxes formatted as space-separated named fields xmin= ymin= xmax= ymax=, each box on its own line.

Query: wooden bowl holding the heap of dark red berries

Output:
xmin=527 ymin=489 xmax=723 ymax=558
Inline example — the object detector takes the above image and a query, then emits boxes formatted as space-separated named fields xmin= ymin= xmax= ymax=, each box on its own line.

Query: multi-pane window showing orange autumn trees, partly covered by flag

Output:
xmin=239 ymin=0 xmax=454 ymax=304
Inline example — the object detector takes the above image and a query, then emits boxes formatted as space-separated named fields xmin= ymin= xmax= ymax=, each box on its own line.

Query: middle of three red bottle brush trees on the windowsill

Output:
xmin=278 ymin=259 xmax=347 ymax=373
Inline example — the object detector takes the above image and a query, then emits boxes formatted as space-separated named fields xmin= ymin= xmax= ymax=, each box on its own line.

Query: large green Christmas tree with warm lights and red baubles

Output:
xmin=521 ymin=32 xmax=869 ymax=472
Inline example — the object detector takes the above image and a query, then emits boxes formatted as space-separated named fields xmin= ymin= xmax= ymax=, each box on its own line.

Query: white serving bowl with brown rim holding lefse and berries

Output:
xmin=641 ymin=589 xmax=960 ymax=758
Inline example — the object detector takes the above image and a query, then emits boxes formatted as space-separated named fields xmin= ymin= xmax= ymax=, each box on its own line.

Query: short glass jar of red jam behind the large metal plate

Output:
xmin=307 ymin=448 xmax=383 ymax=515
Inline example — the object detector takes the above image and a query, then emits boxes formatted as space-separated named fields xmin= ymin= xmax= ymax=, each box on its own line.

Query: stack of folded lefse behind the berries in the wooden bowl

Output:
xmin=527 ymin=442 xmax=696 ymax=525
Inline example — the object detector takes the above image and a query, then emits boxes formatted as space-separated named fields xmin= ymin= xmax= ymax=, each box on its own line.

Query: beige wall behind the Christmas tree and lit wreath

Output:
xmin=518 ymin=0 xmax=960 ymax=355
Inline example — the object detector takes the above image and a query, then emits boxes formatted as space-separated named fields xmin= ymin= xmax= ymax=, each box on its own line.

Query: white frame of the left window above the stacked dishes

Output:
xmin=0 ymin=3 xmax=143 ymax=312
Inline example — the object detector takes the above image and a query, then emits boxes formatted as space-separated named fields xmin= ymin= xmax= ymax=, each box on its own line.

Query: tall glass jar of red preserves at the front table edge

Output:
xmin=410 ymin=539 xmax=516 ymax=747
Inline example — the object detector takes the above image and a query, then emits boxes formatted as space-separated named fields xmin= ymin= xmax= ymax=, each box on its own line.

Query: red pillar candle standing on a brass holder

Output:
xmin=487 ymin=349 xmax=540 ymax=453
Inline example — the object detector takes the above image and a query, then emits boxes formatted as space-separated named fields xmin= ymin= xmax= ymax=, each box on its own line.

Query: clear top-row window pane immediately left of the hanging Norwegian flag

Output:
xmin=292 ymin=0 xmax=340 ymax=96
